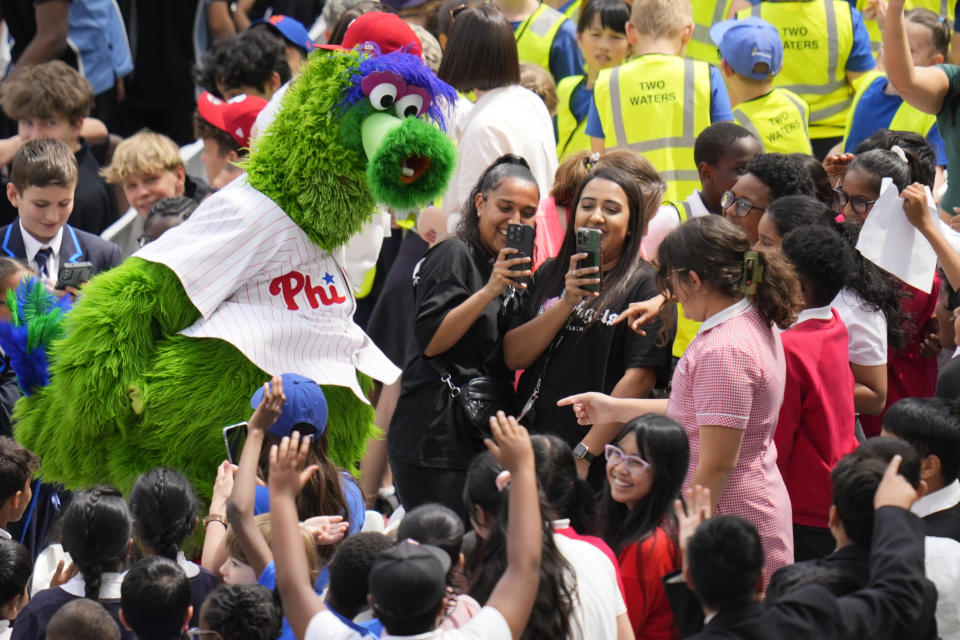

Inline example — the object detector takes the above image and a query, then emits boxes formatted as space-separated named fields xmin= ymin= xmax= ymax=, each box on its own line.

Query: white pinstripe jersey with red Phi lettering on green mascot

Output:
xmin=135 ymin=178 xmax=400 ymax=401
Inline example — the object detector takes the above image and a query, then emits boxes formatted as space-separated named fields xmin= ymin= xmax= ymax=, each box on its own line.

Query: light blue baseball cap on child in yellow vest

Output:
xmin=710 ymin=16 xmax=783 ymax=80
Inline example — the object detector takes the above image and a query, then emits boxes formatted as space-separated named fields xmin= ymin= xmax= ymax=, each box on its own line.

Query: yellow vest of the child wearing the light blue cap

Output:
xmin=733 ymin=88 xmax=813 ymax=154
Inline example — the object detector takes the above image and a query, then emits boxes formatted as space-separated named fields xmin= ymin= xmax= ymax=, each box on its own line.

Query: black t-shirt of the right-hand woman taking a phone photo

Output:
xmin=509 ymin=260 xmax=673 ymax=453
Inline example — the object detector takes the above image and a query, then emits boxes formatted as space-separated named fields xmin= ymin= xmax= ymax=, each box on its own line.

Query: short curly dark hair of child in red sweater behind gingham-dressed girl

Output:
xmin=782 ymin=225 xmax=856 ymax=307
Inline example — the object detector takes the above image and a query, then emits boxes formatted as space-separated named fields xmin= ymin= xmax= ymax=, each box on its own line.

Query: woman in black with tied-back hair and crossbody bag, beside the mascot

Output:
xmin=387 ymin=154 xmax=540 ymax=522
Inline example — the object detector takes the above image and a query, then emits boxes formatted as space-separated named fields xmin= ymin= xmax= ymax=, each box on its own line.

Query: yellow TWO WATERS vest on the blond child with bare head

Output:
xmin=593 ymin=53 xmax=710 ymax=200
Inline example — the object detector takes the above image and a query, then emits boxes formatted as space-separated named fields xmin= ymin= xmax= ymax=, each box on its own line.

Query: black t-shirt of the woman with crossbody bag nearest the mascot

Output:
xmin=388 ymin=238 xmax=512 ymax=469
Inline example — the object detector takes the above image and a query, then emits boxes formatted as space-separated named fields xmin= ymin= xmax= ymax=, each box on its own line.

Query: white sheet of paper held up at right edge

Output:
xmin=857 ymin=178 xmax=938 ymax=293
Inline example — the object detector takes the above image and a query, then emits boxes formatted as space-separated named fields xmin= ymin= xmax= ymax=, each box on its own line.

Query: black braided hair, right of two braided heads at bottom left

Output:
xmin=130 ymin=467 xmax=197 ymax=560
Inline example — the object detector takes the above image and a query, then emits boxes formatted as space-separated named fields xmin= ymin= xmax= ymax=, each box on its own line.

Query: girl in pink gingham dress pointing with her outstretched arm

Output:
xmin=559 ymin=216 xmax=801 ymax=580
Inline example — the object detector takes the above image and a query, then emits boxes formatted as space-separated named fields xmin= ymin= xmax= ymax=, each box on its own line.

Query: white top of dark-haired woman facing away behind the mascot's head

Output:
xmin=443 ymin=85 xmax=557 ymax=212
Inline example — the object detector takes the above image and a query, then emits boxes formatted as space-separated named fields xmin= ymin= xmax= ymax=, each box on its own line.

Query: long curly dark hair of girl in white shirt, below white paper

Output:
xmin=838 ymin=221 xmax=908 ymax=349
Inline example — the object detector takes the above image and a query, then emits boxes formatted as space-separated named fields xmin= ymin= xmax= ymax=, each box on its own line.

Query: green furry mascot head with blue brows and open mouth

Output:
xmin=246 ymin=45 xmax=456 ymax=251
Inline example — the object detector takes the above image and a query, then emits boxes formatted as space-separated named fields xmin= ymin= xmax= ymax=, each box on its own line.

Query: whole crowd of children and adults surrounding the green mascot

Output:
xmin=0 ymin=0 xmax=960 ymax=640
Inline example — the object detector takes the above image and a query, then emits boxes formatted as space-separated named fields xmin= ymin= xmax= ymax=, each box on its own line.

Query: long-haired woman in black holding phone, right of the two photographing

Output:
xmin=503 ymin=161 xmax=670 ymax=487
